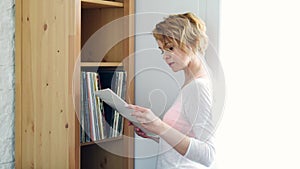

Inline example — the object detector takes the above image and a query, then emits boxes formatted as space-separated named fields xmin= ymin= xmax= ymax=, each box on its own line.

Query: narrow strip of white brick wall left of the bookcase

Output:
xmin=0 ymin=0 xmax=15 ymax=169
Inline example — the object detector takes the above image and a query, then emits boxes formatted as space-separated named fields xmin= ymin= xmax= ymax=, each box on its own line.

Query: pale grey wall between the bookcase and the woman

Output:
xmin=135 ymin=0 xmax=219 ymax=169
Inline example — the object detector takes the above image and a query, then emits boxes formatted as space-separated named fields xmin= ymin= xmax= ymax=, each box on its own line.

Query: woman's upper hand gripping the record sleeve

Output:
xmin=127 ymin=104 xmax=162 ymax=135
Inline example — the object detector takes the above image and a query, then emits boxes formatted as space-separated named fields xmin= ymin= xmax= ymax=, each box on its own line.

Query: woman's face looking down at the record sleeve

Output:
xmin=157 ymin=40 xmax=190 ymax=72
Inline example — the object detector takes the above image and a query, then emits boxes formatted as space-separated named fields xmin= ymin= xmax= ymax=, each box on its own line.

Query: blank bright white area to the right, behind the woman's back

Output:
xmin=216 ymin=0 xmax=300 ymax=169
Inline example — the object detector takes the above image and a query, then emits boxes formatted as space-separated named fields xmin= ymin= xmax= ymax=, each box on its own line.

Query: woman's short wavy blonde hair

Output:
xmin=152 ymin=12 xmax=208 ymax=55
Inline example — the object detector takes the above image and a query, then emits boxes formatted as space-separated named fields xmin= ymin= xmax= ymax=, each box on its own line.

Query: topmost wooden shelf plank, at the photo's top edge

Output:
xmin=81 ymin=0 xmax=124 ymax=8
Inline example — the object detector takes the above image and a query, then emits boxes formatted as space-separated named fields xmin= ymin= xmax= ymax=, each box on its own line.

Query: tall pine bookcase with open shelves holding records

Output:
xmin=15 ymin=0 xmax=134 ymax=169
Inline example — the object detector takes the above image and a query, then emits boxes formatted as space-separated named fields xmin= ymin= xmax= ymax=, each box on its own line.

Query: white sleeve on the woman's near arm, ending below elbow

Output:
xmin=183 ymin=80 xmax=215 ymax=166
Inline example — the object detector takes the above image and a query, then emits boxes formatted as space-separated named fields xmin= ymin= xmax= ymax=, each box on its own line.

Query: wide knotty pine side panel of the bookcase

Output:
xmin=16 ymin=0 xmax=80 ymax=168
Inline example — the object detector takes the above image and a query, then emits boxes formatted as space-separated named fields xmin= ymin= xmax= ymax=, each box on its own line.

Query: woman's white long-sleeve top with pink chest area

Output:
xmin=157 ymin=78 xmax=215 ymax=169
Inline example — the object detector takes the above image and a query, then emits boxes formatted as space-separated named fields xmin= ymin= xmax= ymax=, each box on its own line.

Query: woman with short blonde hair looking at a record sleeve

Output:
xmin=129 ymin=13 xmax=215 ymax=169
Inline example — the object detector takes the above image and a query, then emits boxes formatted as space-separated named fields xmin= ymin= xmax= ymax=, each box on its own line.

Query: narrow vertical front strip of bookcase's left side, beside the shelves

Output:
xmin=65 ymin=0 xmax=81 ymax=169
